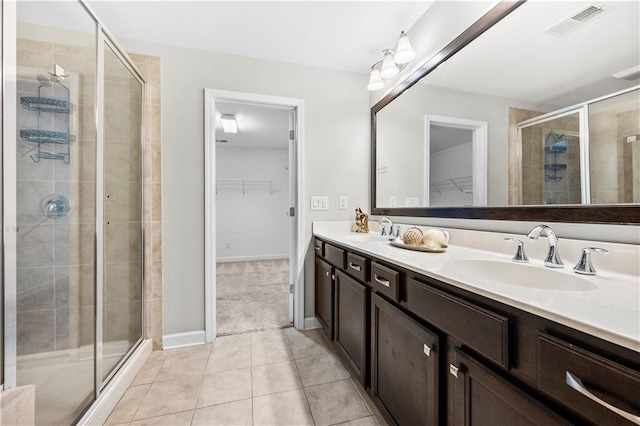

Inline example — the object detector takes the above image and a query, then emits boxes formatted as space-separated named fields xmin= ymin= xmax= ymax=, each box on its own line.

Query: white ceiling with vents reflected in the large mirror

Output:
xmin=423 ymin=1 xmax=640 ymax=107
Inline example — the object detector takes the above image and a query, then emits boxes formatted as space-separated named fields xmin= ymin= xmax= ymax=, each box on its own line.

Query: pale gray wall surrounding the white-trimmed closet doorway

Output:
xmin=120 ymin=40 xmax=369 ymax=335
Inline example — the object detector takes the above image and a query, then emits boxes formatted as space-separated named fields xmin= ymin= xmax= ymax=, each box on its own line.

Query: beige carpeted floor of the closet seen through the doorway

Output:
xmin=216 ymin=259 xmax=292 ymax=336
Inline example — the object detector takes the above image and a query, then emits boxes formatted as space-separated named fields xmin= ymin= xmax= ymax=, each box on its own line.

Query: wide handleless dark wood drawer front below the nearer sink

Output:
xmin=406 ymin=278 xmax=509 ymax=369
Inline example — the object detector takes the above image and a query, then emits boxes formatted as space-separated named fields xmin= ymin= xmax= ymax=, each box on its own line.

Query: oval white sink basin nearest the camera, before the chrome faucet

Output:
xmin=445 ymin=259 xmax=596 ymax=291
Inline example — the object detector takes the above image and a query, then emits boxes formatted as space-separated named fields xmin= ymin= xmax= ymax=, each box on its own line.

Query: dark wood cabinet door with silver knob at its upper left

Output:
xmin=449 ymin=348 xmax=570 ymax=426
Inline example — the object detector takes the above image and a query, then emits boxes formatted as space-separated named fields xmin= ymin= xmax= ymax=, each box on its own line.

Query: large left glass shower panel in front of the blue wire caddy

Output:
xmin=14 ymin=2 xmax=97 ymax=424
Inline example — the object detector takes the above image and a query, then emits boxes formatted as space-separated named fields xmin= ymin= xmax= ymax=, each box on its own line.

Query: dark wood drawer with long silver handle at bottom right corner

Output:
xmin=537 ymin=332 xmax=640 ymax=424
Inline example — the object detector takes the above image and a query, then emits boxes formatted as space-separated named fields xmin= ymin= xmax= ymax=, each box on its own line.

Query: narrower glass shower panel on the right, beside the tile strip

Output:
xmin=99 ymin=42 xmax=144 ymax=382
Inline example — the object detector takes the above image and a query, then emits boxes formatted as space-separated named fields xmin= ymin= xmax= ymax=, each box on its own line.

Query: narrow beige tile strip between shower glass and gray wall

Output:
xmin=129 ymin=54 xmax=162 ymax=350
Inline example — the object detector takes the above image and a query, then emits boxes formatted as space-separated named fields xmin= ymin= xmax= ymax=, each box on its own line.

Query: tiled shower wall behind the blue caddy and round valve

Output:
xmin=16 ymin=39 xmax=96 ymax=355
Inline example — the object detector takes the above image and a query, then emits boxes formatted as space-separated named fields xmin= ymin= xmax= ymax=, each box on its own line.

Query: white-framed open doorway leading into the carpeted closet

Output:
xmin=205 ymin=89 xmax=304 ymax=342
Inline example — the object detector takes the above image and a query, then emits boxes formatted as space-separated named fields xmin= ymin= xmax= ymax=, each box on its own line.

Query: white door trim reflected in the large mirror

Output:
xmin=423 ymin=114 xmax=489 ymax=207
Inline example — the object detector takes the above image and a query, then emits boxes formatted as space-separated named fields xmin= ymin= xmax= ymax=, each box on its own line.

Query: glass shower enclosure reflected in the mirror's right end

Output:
xmin=516 ymin=87 xmax=640 ymax=205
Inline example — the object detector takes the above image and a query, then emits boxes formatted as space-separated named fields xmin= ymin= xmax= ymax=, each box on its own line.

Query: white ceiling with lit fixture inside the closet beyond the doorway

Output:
xmin=216 ymin=102 xmax=292 ymax=149
